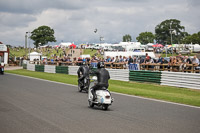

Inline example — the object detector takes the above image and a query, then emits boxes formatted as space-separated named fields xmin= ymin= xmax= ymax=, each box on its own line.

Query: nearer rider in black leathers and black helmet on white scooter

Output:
xmin=91 ymin=62 xmax=110 ymax=101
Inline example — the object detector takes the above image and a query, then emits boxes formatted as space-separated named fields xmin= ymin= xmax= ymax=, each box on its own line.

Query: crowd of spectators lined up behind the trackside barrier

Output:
xmin=41 ymin=54 xmax=199 ymax=71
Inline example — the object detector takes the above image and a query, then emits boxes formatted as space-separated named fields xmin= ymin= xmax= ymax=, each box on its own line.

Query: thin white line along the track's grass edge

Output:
xmin=6 ymin=73 xmax=200 ymax=109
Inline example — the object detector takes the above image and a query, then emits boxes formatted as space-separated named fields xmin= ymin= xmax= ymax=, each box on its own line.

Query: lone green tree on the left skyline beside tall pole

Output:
xmin=30 ymin=26 xmax=56 ymax=48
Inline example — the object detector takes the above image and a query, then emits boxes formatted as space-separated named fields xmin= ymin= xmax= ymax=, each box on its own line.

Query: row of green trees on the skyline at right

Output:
xmin=123 ymin=19 xmax=200 ymax=44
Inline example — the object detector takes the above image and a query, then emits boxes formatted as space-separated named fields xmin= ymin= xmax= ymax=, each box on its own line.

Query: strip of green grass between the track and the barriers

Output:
xmin=6 ymin=69 xmax=200 ymax=106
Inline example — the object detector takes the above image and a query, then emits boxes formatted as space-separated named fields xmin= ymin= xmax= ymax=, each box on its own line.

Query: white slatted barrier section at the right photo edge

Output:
xmin=161 ymin=71 xmax=200 ymax=89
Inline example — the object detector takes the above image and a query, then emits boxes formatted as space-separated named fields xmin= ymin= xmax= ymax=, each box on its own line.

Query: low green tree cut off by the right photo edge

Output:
xmin=182 ymin=32 xmax=200 ymax=44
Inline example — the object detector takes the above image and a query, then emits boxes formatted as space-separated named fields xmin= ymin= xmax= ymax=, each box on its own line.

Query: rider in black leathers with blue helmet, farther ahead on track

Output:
xmin=77 ymin=61 xmax=89 ymax=87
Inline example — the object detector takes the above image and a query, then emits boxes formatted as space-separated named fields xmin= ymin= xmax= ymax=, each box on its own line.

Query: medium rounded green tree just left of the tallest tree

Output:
xmin=136 ymin=32 xmax=155 ymax=44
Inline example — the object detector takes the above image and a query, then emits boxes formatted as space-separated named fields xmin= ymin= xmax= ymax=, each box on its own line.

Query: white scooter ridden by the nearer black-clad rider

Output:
xmin=88 ymin=76 xmax=114 ymax=110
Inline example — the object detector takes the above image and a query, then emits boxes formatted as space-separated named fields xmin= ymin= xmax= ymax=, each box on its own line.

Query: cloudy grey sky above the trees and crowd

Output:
xmin=0 ymin=0 xmax=200 ymax=46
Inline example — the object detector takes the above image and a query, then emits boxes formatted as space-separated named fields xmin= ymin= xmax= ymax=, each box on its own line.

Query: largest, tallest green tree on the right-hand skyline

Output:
xmin=155 ymin=19 xmax=188 ymax=44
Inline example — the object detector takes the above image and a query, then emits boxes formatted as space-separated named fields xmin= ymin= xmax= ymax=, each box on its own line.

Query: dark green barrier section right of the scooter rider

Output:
xmin=129 ymin=71 xmax=161 ymax=83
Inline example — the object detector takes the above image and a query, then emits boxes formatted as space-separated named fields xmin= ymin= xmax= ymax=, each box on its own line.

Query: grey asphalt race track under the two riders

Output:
xmin=0 ymin=73 xmax=200 ymax=133
